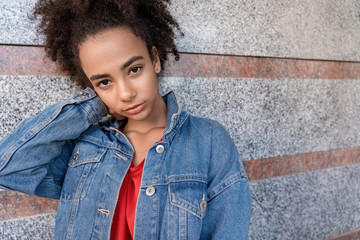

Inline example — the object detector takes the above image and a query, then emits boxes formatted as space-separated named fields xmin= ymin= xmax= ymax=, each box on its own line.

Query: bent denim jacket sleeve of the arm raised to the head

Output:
xmin=0 ymin=89 xmax=107 ymax=198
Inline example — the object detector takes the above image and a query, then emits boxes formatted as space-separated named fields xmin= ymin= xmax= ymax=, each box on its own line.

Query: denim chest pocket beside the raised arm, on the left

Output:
xmin=61 ymin=141 xmax=106 ymax=200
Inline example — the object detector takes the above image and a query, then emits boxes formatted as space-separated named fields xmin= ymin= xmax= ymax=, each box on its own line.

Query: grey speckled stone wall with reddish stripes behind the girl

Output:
xmin=0 ymin=0 xmax=360 ymax=239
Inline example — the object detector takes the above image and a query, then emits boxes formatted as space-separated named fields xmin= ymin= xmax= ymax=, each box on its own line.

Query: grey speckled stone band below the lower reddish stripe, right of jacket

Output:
xmin=249 ymin=165 xmax=360 ymax=240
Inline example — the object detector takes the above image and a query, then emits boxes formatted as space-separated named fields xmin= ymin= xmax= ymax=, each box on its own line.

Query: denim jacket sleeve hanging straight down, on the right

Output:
xmin=201 ymin=125 xmax=251 ymax=240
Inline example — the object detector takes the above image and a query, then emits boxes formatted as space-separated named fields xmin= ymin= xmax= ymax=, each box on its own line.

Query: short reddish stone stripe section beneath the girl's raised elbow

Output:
xmin=0 ymin=190 xmax=58 ymax=221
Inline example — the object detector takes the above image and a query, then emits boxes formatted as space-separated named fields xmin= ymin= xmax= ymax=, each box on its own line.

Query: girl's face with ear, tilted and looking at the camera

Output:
xmin=79 ymin=27 xmax=162 ymax=121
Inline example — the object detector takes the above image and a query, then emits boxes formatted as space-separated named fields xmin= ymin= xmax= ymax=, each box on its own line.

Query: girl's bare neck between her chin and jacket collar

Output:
xmin=124 ymin=94 xmax=167 ymax=133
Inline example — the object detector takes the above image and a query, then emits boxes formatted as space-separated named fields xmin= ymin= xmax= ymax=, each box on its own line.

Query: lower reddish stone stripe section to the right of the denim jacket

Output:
xmin=243 ymin=146 xmax=360 ymax=181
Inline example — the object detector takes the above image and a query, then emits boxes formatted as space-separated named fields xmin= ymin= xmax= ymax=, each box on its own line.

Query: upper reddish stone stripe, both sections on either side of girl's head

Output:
xmin=0 ymin=45 xmax=360 ymax=80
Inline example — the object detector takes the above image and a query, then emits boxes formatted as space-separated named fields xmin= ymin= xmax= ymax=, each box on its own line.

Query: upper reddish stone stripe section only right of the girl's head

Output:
xmin=166 ymin=54 xmax=360 ymax=79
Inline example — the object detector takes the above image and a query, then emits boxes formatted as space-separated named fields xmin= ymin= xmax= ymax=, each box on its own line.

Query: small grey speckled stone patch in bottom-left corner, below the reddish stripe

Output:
xmin=0 ymin=214 xmax=55 ymax=240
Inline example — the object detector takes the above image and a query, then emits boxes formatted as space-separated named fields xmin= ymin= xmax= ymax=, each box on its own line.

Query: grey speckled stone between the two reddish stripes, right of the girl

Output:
xmin=163 ymin=78 xmax=360 ymax=160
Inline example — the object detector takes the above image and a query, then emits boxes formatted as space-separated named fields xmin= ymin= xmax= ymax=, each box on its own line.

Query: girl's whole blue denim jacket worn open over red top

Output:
xmin=0 ymin=89 xmax=251 ymax=240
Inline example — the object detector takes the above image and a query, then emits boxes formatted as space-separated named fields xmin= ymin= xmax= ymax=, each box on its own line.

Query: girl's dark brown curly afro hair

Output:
xmin=32 ymin=0 xmax=182 ymax=88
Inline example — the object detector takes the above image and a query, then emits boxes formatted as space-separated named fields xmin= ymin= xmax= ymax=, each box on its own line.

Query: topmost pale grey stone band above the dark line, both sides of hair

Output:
xmin=0 ymin=0 xmax=360 ymax=61
